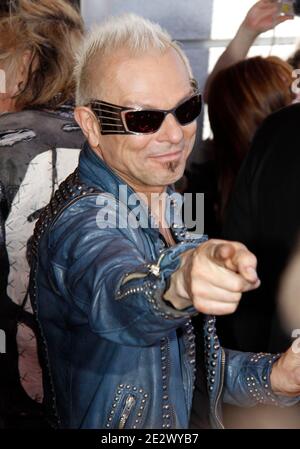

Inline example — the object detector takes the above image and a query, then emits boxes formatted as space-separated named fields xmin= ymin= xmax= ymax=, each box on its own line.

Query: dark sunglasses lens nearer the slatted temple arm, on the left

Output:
xmin=125 ymin=111 xmax=165 ymax=134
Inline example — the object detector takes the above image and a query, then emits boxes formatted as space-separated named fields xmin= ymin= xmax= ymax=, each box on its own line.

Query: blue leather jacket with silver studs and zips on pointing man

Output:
xmin=30 ymin=144 xmax=298 ymax=428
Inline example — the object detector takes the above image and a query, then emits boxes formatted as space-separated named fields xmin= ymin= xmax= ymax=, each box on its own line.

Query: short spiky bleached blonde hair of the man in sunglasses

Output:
xmin=75 ymin=14 xmax=193 ymax=106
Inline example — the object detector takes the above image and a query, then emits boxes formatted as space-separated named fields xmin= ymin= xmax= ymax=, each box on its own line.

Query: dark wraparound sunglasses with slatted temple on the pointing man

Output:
xmin=89 ymin=91 xmax=202 ymax=135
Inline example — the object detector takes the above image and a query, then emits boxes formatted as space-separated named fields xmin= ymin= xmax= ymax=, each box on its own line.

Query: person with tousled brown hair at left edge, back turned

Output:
xmin=0 ymin=0 xmax=84 ymax=427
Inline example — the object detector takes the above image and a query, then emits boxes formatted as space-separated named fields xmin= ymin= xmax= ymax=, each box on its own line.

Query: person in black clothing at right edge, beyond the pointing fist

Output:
xmin=219 ymin=103 xmax=300 ymax=428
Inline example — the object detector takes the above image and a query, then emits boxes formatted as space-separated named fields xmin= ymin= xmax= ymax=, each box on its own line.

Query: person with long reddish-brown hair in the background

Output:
xmin=186 ymin=56 xmax=295 ymax=237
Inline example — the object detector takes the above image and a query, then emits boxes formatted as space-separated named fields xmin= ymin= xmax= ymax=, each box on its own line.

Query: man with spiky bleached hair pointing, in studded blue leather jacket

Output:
xmin=30 ymin=15 xmax=300 ymax=429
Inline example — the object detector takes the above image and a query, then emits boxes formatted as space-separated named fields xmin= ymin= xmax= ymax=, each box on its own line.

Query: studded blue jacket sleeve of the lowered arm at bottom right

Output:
xmin=223 ymin=349 xmax=300 ymax=407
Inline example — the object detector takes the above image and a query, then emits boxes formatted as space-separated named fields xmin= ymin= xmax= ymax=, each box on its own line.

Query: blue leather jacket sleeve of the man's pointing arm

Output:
xmin=48 ymin=194 xmax=206 ymax=346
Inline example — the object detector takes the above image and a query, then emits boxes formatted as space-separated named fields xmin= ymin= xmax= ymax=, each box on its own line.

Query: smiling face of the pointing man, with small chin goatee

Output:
xmin=92 ymin=49 xmax=196 ymax=191
